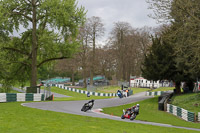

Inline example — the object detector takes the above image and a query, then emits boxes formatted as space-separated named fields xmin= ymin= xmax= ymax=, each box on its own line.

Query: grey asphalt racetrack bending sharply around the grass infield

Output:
xmin=22 ymin=92 xmax=200 ymax=131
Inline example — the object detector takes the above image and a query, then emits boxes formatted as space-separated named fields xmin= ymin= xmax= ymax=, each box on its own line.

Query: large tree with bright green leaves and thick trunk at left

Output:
xmin=0 ymin=0 xmax=85 ymax=86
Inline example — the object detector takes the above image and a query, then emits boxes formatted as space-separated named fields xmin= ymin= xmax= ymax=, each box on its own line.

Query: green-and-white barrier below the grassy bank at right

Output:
xmin=167 ymin=104 xmax=195 ymax=122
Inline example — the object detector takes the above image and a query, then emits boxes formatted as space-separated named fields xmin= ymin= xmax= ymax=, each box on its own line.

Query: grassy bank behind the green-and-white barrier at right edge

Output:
xmin=171 ymin=93 xmax=200 ymax=114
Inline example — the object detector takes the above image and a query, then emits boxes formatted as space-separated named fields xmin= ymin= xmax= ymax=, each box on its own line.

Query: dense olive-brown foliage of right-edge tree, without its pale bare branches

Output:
xmin=170 ymin=0 xmax=200 ymax=79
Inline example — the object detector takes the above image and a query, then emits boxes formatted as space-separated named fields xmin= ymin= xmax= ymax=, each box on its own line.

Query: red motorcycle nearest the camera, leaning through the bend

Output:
xmin=121 ymin=108 xmax=138 ymax=120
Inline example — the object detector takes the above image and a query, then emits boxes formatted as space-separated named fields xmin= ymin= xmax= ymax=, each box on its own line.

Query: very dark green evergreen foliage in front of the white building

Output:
xmin=142 ymin=37 xmax=176 ymax=81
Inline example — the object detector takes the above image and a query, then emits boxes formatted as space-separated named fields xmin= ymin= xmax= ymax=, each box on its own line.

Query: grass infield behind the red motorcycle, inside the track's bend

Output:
xmin=103 ymin=97 xmax=200 ymax=129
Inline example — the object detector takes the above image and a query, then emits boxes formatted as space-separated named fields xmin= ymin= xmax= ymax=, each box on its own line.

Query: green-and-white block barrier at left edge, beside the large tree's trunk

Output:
xmin=0 ymin=93 xmax=44 ymax=102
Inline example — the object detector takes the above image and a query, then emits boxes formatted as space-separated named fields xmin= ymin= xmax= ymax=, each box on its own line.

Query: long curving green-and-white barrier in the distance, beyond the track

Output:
xmin=50 ymin=84 xmax=117 ymax=97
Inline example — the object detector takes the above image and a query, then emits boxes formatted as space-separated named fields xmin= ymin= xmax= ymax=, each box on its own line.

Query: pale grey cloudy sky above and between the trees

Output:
xmin=77 ymin=0 xmax=158 ymax=42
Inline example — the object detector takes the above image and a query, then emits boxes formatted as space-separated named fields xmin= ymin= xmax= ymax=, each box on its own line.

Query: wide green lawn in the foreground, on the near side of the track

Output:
xmin=0 ymin=102 xmax=197 ymax=133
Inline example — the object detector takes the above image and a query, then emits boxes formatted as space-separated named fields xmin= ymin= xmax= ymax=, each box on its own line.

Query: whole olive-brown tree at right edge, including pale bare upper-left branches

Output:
xmin=149 ymin=0 xmax=200 ymax=90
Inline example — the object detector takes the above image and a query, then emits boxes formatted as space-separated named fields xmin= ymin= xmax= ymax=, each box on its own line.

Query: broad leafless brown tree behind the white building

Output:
xmin=110 ymin=22 xmax=150 ymax=81
